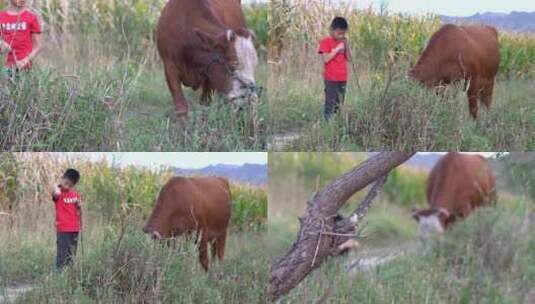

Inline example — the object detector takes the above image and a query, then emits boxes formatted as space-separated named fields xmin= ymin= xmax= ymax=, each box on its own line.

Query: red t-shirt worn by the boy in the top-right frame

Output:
xmin=318 ymin=36 xmax=348 ymax=81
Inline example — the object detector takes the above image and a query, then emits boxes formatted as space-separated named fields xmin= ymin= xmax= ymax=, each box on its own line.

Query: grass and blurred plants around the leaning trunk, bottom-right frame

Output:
xmin=268 ymin=153 xmax=535 ymax=303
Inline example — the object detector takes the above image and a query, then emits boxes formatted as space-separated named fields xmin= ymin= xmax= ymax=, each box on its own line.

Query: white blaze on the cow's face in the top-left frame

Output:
xmin=226 ymin=36 xmax=258 ymax=106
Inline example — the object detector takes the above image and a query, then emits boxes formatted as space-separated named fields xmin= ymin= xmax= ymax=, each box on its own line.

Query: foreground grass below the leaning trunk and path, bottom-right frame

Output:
xmin=272 ymin=196 xmax=535 ymax=303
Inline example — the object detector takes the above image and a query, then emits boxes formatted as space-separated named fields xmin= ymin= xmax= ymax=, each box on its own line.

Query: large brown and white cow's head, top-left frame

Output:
xmin=195 ymin=29 xmax=258 ymax=106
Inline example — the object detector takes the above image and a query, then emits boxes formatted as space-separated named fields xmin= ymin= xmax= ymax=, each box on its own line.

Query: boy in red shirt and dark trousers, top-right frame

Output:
xmin=318 ymin=17 xmax=350 ymax=119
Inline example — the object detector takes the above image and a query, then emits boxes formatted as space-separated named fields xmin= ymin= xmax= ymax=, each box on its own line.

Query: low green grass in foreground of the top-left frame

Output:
xmin=0 ymin=56 xmax=266 ymax=151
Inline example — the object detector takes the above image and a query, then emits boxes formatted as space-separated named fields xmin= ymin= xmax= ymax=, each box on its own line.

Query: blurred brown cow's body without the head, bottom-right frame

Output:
xmin=427 ymin=152 xmax=495 ymax=217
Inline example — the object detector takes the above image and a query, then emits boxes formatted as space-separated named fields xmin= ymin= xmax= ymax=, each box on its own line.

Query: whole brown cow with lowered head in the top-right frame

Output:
xmin=409 ymin=24 xmax=500 ymax=119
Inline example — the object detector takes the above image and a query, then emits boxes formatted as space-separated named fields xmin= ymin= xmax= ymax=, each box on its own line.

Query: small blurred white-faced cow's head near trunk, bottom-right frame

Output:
xmin=412 ymin=208 xmax=455 ymax=237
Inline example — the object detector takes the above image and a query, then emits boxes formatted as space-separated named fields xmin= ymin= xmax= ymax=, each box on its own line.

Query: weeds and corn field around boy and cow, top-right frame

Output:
xmin=269 ymin=1 xmax=535 ymax=151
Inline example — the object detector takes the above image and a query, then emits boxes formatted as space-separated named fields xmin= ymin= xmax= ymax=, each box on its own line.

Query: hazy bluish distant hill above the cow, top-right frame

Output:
xmin=440 ymin=11 xmax=535 ymax=34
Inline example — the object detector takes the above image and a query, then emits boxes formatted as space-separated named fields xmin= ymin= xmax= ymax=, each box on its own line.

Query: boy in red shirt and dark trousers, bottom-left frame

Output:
xmin=52 ymin=169 xmax=82 ymax=270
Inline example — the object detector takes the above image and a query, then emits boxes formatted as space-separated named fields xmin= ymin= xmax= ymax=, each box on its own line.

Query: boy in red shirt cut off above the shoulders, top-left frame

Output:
xmin=0 ymin=0 xmax=42 ymax=71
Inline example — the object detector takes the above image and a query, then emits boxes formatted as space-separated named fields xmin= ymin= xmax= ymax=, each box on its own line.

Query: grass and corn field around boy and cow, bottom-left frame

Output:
xmin=0 ymin=153 xmax=269 ymax=303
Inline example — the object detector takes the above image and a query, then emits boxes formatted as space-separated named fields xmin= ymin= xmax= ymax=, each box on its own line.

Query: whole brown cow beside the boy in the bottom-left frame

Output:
xmin=143 ymin=177 xmax=232 ymax=270
